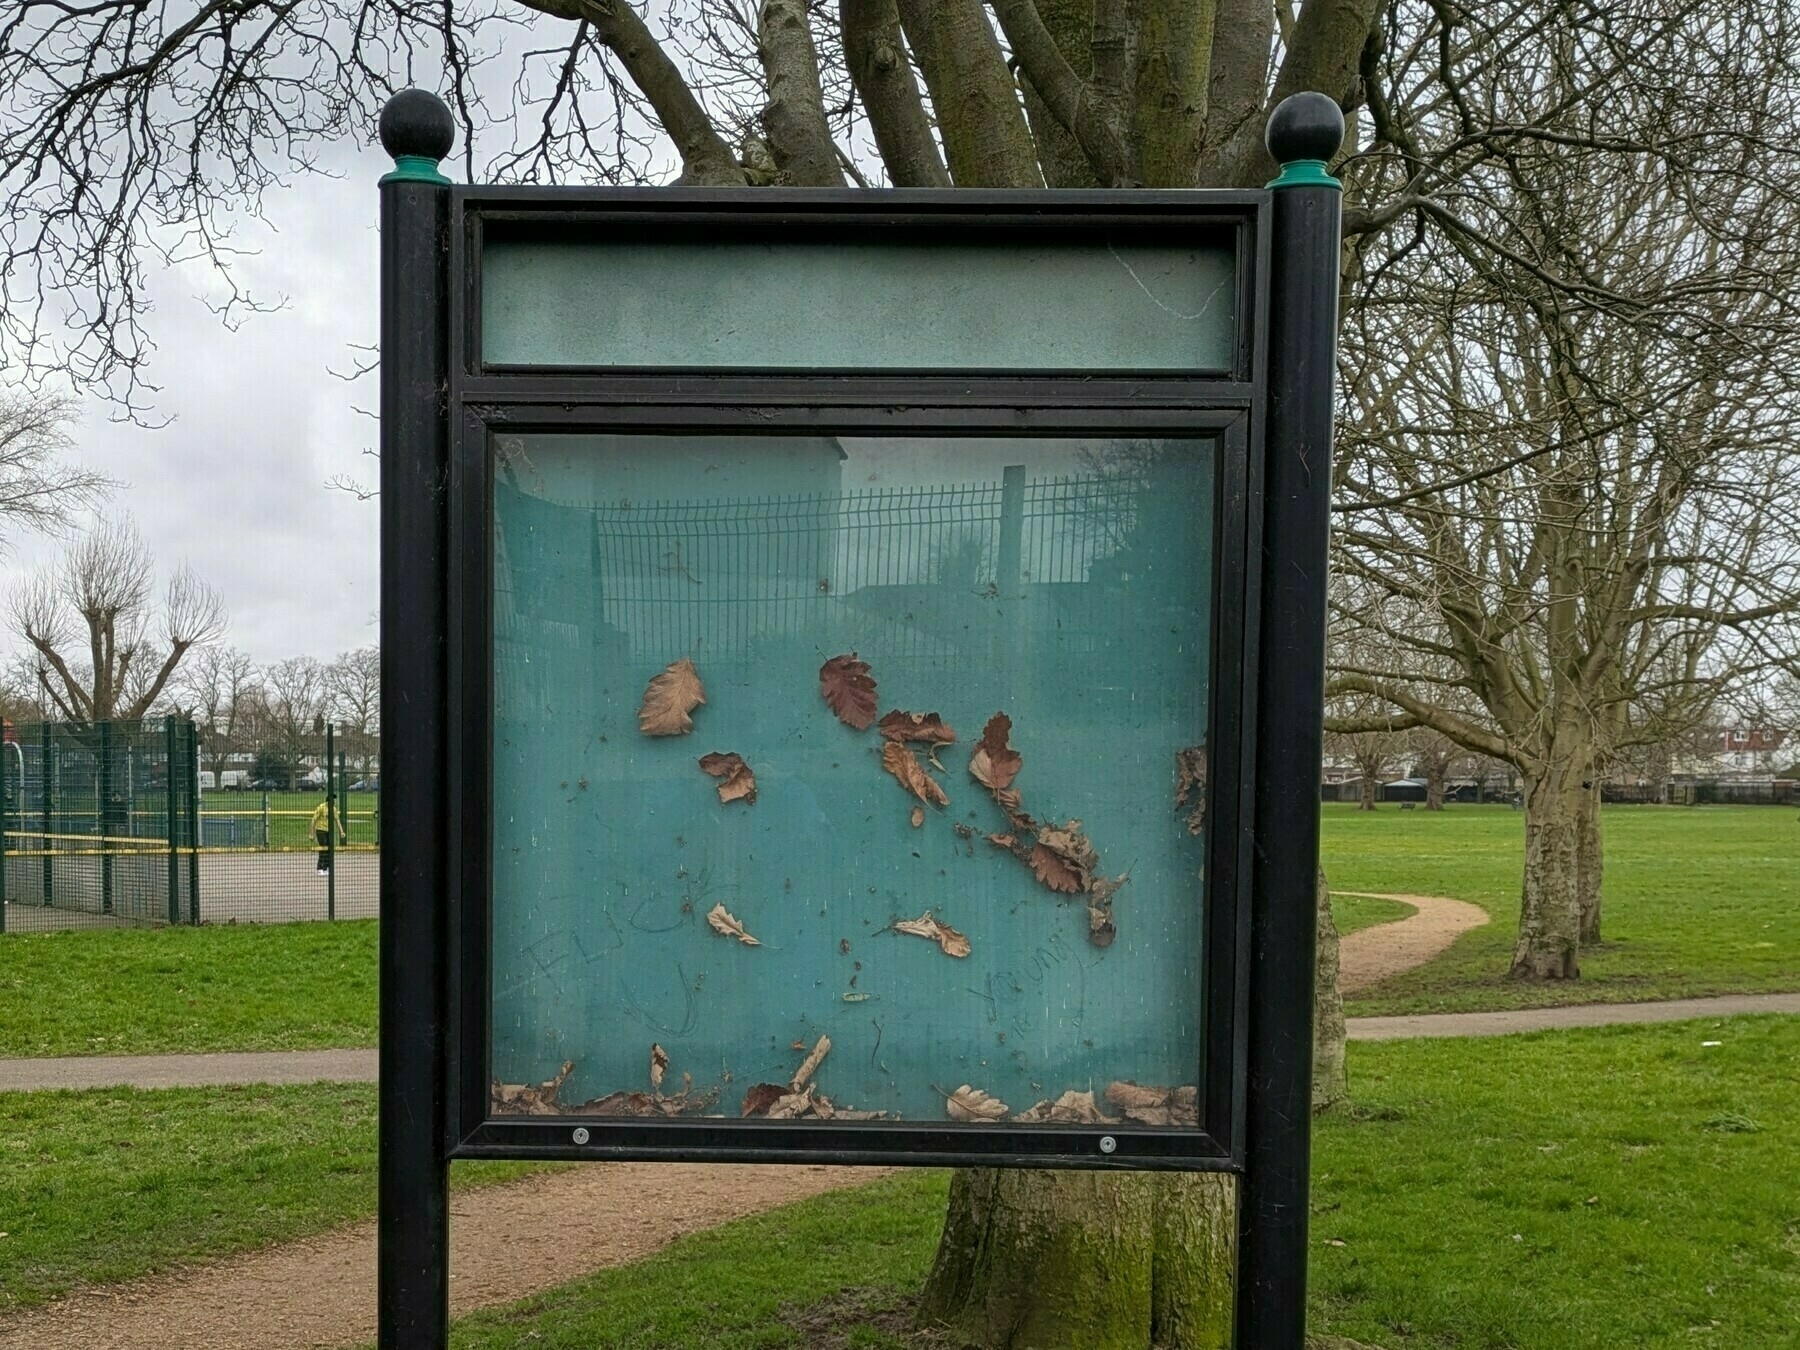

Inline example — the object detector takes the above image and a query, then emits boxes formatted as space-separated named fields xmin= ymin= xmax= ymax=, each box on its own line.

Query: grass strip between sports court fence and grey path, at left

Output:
xmin=0 ymin=920 xmax=376 ymax=1058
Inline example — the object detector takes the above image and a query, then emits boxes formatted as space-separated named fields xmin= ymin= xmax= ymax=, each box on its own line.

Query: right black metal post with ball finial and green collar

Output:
xmin=1237 ymin=94 xmax=1345 ymax=1350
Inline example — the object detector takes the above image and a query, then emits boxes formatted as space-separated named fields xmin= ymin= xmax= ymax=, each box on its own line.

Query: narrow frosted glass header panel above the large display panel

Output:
xmin=481 ymin=236 xmax=1237 ymax=373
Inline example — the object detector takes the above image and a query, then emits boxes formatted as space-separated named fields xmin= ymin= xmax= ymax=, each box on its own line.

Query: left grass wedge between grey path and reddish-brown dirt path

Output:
xmin=0 ymin=1084 xmax=527 ymax=1309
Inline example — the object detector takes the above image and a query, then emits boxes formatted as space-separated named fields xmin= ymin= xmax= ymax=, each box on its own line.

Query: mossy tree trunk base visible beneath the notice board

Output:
xmin=920 ymin=1168 xmax=1237 ymax=1350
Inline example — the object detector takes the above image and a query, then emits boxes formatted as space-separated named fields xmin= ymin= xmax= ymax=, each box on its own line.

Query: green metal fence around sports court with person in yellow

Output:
xmin=0 ymin=718 xmax=380 ymax=932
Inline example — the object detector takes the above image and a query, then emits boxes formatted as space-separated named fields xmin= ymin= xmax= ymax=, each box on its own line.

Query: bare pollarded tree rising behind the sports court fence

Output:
xmin=11 ymin=517 xmax=225 ymax=722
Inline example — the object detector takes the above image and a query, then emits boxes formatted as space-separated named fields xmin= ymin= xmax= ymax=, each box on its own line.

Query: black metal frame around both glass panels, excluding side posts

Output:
xmin=430 ymin=189 xmax=1267 ymax=1170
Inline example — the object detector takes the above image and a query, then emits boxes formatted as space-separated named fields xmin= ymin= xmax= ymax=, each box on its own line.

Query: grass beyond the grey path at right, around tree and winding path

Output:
xmin=1323 ymin=803 xmax=1800 ymax=1017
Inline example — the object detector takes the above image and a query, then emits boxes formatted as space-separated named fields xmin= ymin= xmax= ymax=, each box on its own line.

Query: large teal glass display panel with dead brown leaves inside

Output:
xmin=490 ymin=434 xmax=1217 ymax=1129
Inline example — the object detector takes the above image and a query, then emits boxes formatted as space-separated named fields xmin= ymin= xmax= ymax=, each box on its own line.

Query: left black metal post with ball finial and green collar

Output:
xmin=376 ymin=90 xmax=455 ymax=1350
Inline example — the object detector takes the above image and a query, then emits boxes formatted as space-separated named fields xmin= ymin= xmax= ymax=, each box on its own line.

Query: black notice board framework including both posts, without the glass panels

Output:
xmin=380 ymin=182 xmax=1339 ymax=1350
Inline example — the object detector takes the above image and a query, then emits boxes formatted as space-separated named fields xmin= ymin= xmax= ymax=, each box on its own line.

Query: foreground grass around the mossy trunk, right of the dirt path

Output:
xmin=412 ymin=1017 xmax=1800 ymax=1350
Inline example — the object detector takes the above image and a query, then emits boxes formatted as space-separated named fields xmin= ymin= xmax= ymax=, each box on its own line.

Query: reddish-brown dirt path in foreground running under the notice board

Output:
xmin=0 ymin=1163 xmax=884 ymax=1350
